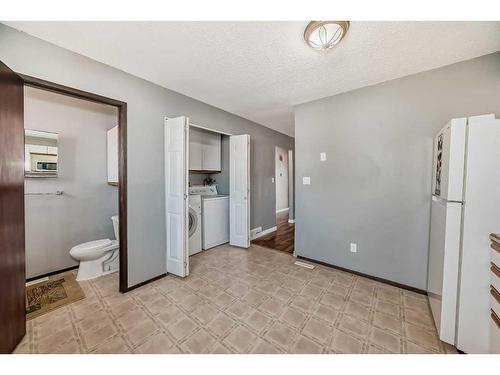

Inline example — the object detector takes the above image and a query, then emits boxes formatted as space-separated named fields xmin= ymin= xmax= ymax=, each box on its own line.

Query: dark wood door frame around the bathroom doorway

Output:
xmin=16 ymin=73 xmax=129 ymax=293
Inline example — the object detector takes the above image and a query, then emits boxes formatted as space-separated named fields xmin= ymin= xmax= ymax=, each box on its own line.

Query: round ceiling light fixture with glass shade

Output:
xmin=304 ymin=21 xmax=350 ymax=51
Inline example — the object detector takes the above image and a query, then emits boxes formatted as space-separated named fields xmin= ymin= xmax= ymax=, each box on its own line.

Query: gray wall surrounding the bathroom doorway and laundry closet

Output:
xmin=0 ymin=25 xmax=293 ymax=285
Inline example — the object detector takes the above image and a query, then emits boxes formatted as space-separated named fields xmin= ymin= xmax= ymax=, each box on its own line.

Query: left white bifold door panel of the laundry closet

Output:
xmin=165 ymin=116 xmax=189 ymax=277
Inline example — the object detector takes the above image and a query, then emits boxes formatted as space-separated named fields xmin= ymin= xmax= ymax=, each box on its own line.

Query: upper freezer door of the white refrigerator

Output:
xmin=432 ymin=118 xmax=467 ymax=202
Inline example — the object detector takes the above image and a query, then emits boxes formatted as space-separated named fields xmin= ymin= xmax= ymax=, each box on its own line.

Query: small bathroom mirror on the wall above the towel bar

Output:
xmin=24 ymin=129 xmax=58 ymax=177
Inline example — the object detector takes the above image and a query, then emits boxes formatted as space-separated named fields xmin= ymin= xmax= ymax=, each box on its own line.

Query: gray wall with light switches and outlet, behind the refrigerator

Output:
xmin=295 ymin=53 xmax=500 ymax=289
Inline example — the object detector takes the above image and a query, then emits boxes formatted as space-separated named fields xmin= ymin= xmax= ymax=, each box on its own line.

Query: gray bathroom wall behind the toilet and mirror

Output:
xmin=24 ymin=87 xmax=118 ymax=278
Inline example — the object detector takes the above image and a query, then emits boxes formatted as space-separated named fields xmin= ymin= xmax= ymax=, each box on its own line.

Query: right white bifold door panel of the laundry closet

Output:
xmin=229 ymin=134 xmax=250 ymax=248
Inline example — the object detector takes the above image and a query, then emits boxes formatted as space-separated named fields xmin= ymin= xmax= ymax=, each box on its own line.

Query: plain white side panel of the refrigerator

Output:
xmin=457 ymin=115 xmax=500 ymax=353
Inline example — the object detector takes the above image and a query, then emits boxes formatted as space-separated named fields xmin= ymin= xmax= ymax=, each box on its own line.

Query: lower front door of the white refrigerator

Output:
xmin=427 ymin=196 xmax=462 ymax=345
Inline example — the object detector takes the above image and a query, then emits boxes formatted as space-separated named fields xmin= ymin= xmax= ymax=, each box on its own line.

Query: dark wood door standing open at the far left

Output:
xmin=0 ymin=61 xmax=26 ymax=353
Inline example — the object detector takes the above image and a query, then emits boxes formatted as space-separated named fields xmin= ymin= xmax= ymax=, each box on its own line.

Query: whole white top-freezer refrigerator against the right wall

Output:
xmin=427 ymin=114 xmax=500 ymax=353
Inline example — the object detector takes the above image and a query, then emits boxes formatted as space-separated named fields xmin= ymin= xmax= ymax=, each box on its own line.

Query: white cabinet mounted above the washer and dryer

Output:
xmin=189 ymin=128 xmax=221 ymax=172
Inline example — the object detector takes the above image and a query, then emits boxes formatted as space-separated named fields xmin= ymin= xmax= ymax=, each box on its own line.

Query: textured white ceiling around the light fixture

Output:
xmin=7 ymin=22 xmax=500 ymax=136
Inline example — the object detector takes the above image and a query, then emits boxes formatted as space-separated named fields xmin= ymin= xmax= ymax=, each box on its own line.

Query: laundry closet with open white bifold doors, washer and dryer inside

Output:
xmin=165 ymin=116 xmax=250 ymax=277
